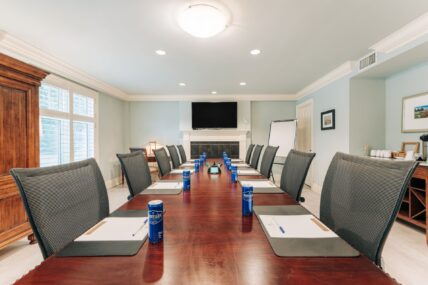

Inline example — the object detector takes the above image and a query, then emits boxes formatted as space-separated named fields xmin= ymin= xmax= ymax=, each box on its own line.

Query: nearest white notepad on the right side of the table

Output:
xmin=259 ymin=215 xmax=337 ymax=238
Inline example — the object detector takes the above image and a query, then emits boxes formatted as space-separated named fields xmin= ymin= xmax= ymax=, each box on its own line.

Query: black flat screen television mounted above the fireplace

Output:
xmin=192 ymin=102 xmax=238 ymax=130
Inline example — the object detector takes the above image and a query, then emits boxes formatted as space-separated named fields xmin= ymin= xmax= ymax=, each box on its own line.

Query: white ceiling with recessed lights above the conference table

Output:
xmin=0 ymin=0 xmax=428 ymax=94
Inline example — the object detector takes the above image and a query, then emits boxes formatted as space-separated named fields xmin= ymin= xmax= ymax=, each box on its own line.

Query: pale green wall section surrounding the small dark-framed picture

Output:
xmin=298 ymin=77 xmax=350 ymax=190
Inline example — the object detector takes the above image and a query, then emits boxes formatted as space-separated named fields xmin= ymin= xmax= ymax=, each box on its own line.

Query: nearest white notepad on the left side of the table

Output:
xmin=74 ymin=217 xmax=149 ymax=242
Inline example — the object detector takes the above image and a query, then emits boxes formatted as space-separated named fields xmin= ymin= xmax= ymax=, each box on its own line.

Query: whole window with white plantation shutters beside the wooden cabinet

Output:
xmin=39 ymin=76 xmax=97 ymax=166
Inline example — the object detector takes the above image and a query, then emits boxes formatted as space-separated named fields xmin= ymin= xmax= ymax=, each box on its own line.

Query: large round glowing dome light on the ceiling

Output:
xmin=178 ymin=3 xmax=229 ymax=38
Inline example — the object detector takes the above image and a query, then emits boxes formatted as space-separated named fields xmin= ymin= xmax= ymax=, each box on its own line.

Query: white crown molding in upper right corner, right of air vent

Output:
xmin=370 ymin=13 xmax=428 ymax=53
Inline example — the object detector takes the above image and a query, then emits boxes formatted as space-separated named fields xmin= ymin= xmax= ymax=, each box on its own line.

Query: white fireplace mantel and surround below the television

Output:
xmin=182 ymin=129 xmax=250 ymax=159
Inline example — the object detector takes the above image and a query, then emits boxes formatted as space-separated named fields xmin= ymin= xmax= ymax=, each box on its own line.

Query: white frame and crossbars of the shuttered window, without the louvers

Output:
xmin=39 ymin=74 xmax=99 ymax=162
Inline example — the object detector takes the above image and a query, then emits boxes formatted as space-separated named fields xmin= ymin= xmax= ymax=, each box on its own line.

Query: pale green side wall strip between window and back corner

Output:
xmin=98 ymin=94 xmax=127 ymax=181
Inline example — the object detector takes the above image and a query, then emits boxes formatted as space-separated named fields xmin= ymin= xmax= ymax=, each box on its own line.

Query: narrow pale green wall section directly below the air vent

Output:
xmin=349 ymin=78 xmax=385 ymax=155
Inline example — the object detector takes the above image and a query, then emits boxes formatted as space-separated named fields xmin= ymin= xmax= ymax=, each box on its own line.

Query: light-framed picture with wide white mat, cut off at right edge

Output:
xmin=401 ymin=93 xmax=428 ymax=133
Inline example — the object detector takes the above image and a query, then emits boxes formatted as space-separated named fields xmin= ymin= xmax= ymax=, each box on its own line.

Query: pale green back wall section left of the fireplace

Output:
xmin=127 ymin=102 xmax=181 ymax=147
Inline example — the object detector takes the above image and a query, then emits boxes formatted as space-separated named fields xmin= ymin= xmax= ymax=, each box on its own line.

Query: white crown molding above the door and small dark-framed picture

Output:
xmin=295 ymin=61 xmax=354 ymax=100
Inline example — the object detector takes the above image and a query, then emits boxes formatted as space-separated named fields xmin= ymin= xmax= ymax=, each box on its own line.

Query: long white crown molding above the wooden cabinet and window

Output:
xmin=0 ymin=30 xmax=129 ymax=100
